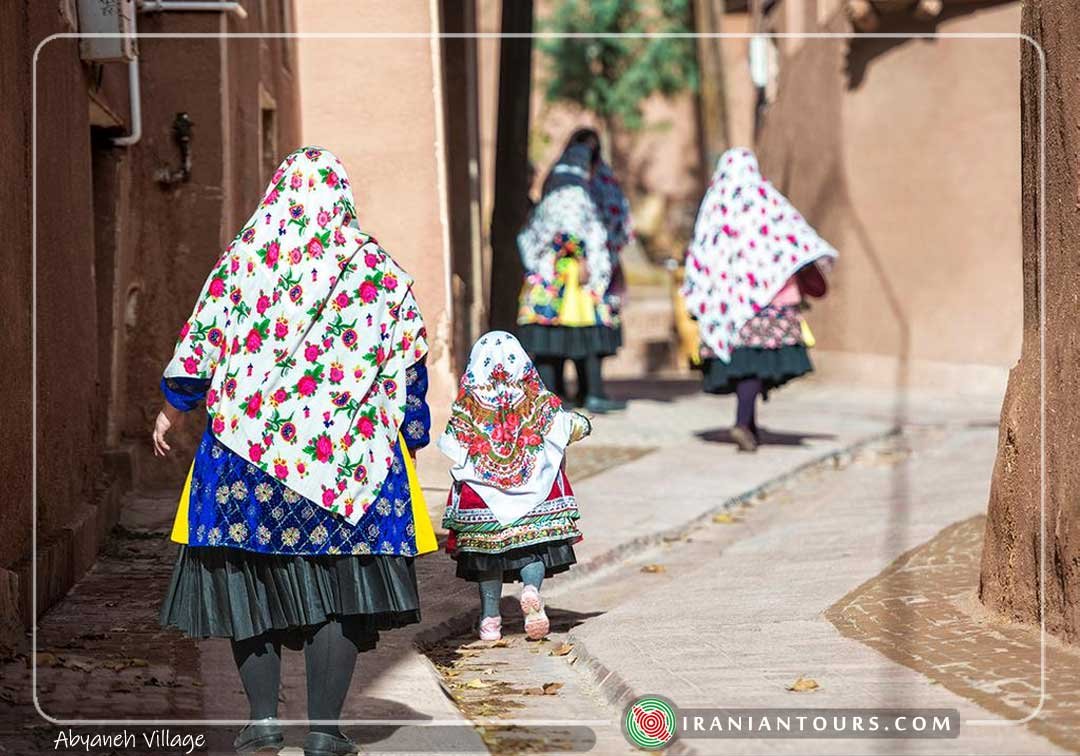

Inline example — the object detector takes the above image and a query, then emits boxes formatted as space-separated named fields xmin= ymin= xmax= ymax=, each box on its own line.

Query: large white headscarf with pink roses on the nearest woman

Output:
xmin=165 ymin=147 xmax=427 ymax=524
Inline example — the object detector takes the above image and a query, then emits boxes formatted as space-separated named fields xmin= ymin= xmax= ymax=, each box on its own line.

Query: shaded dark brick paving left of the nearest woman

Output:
xmin=0 ymin=516 xmax=223 ymax=755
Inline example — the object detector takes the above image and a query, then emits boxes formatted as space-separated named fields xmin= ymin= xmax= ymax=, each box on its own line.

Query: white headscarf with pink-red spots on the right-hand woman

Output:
xmin=683 ymin=148 xmax=837 ymax=362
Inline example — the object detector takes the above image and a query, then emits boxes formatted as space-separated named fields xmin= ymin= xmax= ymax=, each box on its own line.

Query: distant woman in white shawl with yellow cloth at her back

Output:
xmin=517 ymin=144 xmax=624 ymax=413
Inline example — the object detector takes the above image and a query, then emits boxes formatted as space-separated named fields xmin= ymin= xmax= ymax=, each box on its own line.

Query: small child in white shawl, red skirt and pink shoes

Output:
xmin=438 ymin=330 xmax=592 ymax=640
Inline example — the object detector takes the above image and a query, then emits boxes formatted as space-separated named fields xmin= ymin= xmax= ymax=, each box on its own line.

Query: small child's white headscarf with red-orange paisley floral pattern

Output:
xmin=438 ymin=330 xmax=573 ymax=524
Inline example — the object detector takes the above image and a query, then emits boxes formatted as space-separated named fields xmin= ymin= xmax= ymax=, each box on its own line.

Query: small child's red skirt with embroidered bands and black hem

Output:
xmin=443 ymin=473 xmax=581 ymax=582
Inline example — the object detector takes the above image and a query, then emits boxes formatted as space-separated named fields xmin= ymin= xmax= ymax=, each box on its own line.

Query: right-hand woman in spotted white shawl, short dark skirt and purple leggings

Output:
xmin=683 ymin=148 xmax=837 ymax=451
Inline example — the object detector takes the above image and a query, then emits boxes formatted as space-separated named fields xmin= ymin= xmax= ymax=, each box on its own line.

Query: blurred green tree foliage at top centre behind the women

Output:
xmin=538 ymin=0 xmax=698 ymax=162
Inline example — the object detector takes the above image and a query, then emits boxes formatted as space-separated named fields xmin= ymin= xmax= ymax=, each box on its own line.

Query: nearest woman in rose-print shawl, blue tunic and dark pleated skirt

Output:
xmin=153 ymin=148 xmax=435 ymax=756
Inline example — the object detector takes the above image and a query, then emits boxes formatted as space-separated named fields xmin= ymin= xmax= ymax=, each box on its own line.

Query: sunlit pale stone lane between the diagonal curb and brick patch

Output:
xmin=559 ymin=423 xmax=1067 ymax=754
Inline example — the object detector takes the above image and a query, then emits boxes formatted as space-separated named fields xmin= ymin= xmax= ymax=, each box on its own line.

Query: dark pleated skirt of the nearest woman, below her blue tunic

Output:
xmin=161 ymin=546 xmax=420 ymax=640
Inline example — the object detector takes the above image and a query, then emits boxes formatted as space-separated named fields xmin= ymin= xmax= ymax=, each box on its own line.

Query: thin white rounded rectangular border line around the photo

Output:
xmin=30 ymin=29 xmax=1047 ymax=727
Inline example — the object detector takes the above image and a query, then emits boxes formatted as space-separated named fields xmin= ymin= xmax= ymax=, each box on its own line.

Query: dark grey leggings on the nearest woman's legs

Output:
xmin=232 ymin=620 xmax=362 ymax=735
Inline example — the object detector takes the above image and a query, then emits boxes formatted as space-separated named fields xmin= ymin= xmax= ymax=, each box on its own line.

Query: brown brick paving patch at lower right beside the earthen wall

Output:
xmin=826 ymin=516 xmax=1080 ymax=752
